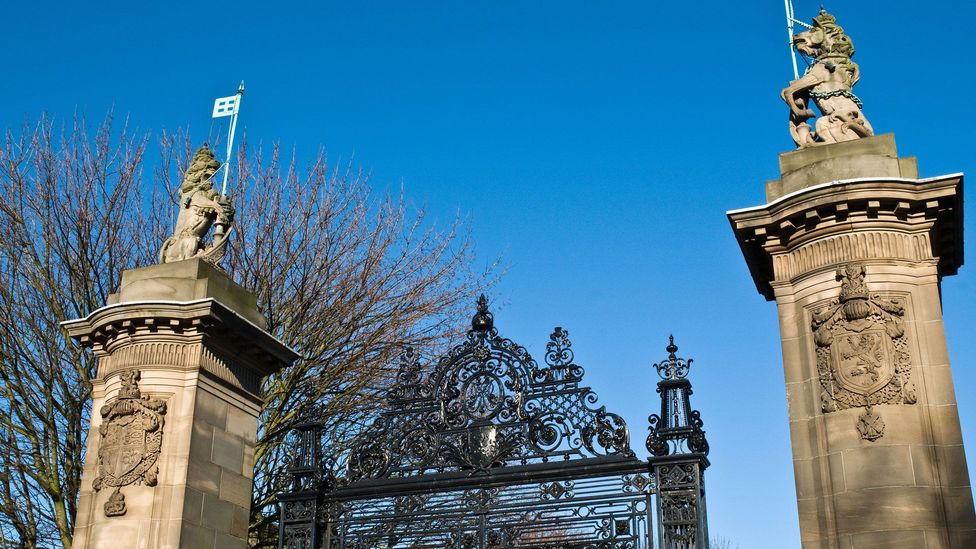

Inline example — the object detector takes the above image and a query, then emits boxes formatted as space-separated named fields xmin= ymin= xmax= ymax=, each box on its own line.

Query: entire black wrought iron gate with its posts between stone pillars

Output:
xmin=278 ymin=296 xmax=708 ymax=549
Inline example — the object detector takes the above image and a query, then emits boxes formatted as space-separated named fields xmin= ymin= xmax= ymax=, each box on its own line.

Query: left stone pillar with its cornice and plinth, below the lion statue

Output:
xmin=63 ymin=260 xmax=296 ymax=548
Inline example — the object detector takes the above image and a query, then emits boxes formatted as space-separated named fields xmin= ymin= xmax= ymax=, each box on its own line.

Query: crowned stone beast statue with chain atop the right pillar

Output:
xmin=782 ymin=8 xmax=874 ymax=148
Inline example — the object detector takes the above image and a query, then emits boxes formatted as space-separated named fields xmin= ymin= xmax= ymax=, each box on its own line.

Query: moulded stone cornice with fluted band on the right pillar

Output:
xmin=727 ymin=174 xmax=963 ymax=300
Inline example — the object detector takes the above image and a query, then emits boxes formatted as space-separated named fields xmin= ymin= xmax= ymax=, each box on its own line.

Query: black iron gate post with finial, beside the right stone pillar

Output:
xmin=647 ymin=336 xmax=709 ymax=549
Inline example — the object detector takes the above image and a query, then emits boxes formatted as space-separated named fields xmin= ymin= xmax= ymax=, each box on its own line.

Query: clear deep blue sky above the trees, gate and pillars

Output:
xmin=0 ymin=0 xmax=976 ymax=549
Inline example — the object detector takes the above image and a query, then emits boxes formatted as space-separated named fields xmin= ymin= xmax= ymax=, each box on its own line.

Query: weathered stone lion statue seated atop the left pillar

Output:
xmin=159 ymin=145 xmax=234 ymax=265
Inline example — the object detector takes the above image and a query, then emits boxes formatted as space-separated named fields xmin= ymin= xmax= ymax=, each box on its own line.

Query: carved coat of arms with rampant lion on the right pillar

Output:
xmin=812 ymin=263 xmax=916 ymax=441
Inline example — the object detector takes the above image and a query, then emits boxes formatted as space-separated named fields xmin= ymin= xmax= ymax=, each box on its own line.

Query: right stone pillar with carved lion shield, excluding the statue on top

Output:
xmin=728 ymin=135 xmax=976 ymax=549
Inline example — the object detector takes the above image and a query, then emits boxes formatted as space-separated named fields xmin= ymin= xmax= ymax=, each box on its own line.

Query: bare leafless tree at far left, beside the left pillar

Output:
xmin=0 ymin=113 xmax=154 ymax=547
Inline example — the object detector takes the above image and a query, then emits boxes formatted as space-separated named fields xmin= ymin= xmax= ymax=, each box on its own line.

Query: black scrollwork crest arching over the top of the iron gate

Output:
xmin=346 ymin=296 xmax=633 ymax=480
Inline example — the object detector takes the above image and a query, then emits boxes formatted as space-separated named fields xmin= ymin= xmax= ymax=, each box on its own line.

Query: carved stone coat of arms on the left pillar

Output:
xmin=93 ymin=370 xmax=166 ymax=517
